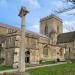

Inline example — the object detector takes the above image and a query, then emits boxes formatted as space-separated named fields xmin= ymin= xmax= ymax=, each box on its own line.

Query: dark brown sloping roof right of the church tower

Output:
xmin=57 ymin=31 xmax=75 ymax=44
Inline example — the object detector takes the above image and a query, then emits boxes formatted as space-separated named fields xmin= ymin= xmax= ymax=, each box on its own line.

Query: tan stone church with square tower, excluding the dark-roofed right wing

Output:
xmin=0 ymin=9 xmax=65 ymax=66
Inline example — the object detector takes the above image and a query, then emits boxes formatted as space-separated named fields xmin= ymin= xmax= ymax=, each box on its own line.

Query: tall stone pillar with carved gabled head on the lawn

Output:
xmin=19 ymin=7 xmax=28 ymax=72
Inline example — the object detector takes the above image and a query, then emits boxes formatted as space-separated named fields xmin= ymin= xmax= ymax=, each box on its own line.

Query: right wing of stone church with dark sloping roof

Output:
xmin=57 ymin=31 xmax=75 ymax=61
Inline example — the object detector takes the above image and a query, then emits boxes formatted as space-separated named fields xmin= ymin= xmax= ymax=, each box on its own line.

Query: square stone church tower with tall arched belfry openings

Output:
xmin=40 ymin=14 xmax=63 ymax=44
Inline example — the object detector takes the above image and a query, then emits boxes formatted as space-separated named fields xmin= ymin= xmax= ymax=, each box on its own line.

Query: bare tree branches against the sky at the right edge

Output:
xmin=53 ymin=0 xmax=75 ymax=32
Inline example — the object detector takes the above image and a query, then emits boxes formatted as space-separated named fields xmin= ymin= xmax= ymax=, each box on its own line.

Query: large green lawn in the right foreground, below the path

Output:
xmin=27 ymin=63 xmax=75 ymax=75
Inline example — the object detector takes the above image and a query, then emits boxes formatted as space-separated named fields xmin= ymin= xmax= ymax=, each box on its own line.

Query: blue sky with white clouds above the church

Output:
xmin=0 ymin=0 xmax=75 ymax=32
